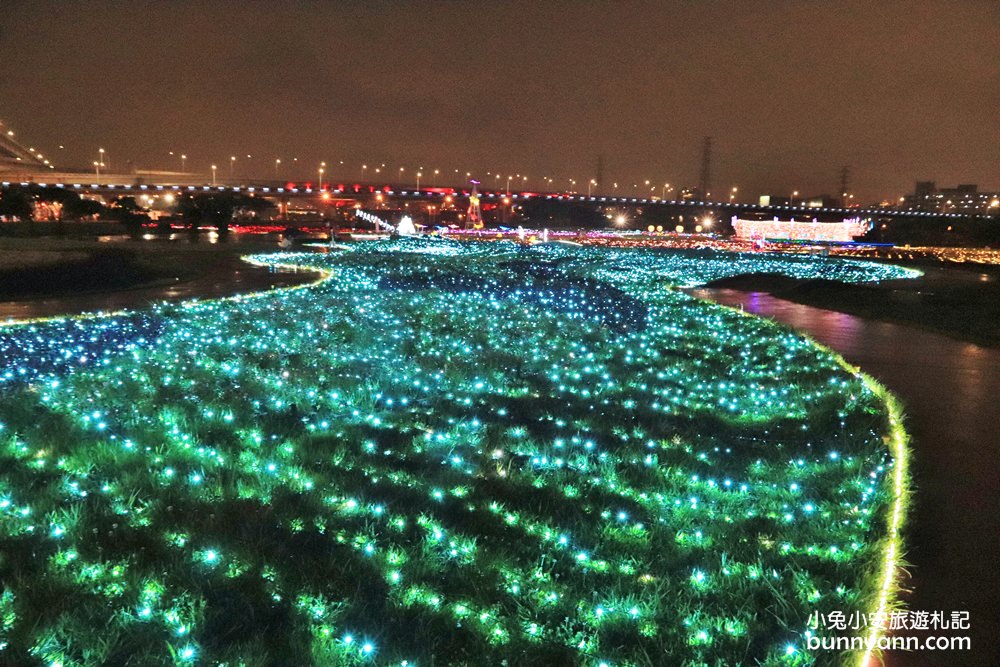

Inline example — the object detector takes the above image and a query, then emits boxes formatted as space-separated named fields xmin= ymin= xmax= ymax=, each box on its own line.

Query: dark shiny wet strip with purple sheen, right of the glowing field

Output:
xmin=692 ymin=290 xmax=1000 ymax=667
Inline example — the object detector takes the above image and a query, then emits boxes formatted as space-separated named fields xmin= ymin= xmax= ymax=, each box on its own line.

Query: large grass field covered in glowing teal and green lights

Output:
xmin=0 ymin=238 xmax=909 ymax=667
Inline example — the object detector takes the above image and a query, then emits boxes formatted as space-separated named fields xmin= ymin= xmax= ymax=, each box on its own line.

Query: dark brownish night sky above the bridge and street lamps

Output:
xmin=0 ymin=0 xmax=1000 ymax=201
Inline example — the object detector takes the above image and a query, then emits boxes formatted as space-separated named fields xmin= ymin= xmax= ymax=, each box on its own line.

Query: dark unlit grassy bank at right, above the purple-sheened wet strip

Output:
xmin=706 ymin=267 xmax=1000 ymax=348
